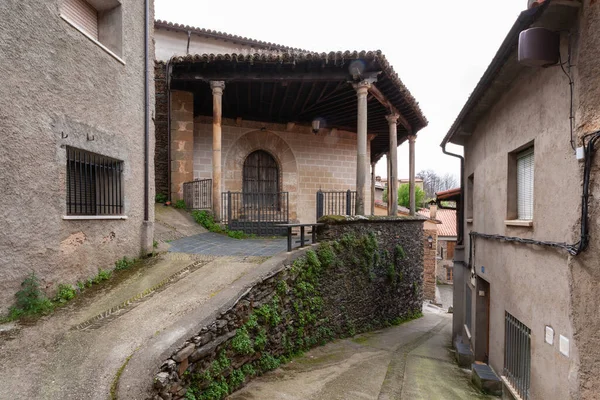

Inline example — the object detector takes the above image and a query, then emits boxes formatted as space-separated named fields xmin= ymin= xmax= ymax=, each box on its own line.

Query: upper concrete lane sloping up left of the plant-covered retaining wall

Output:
xmin=0 ymin=253 xmax=284 ymax=400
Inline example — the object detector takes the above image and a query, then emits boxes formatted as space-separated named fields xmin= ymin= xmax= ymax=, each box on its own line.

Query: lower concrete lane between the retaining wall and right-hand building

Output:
xmin=229 ymin=307 xmax=492 ymax=400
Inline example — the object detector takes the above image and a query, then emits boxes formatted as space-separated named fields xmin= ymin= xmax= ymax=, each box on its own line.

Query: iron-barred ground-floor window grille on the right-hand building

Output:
xmin=504 ymin=312 xmax=531 ymax=400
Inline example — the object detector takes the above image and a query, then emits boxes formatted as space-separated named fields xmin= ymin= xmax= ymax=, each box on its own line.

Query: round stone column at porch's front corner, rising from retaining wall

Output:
xmin=354 ymin=80 xmax=371 ymax=215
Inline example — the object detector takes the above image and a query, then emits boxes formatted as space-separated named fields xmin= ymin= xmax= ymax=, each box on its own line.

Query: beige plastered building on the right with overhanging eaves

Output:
xmin=442 ymin=0 xmax=600 ymax=399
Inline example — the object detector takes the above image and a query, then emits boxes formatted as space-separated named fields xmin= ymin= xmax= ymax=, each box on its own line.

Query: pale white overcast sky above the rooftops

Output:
xmin=155 ymin=0 xmax=527 ymax=178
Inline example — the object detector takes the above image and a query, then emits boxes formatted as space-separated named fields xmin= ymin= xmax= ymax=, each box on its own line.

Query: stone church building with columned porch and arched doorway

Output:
xmin=155 ymin=21 xmax=427 ymax=232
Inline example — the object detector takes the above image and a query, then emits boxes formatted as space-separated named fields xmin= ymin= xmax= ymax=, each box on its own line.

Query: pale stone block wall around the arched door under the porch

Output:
xmin=194 ymin=117 xmax=371 ymax=223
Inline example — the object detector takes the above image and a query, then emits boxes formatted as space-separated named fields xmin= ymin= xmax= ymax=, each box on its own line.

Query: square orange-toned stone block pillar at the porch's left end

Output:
xmin=169 ymin=90 xmax=194 ymax=202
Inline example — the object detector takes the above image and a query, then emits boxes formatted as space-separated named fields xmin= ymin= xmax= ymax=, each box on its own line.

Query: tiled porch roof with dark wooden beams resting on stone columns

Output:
xmin=171 ymin=51 xmax=427 ymax=160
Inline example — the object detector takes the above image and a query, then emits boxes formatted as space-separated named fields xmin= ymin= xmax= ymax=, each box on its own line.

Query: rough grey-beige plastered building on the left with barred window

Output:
xmin=0 ymin=0 xmax=154 ymax=312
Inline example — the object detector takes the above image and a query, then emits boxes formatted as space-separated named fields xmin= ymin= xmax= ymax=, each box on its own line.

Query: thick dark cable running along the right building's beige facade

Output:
xmin=469 ymin=130 xmax=600 ymax=267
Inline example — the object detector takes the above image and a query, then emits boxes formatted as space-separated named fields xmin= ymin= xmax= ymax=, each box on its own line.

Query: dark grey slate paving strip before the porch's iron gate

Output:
xmin=169 ymin=232 xmax=287 ymax=257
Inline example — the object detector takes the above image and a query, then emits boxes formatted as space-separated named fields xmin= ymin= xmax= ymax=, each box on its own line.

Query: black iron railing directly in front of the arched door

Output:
xmin=221 ymin=192 xmax=290 ymax=235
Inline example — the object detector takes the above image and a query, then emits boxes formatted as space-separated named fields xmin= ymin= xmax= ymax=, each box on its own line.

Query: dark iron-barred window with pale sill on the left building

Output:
xmin=67 ymin=147 xmax=123 ymax=216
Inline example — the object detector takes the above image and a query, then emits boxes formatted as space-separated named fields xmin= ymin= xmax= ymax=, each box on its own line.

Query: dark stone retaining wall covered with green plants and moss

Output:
xmin=154 ymin=218 xmax=423 ymax=399
